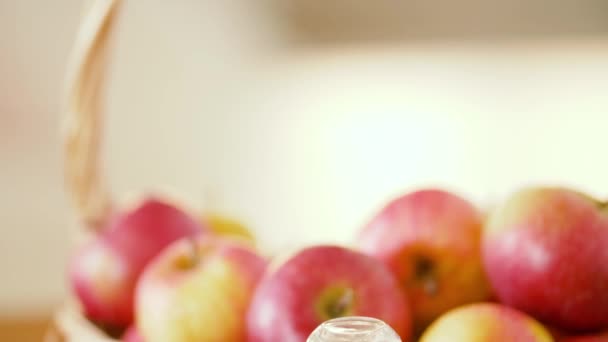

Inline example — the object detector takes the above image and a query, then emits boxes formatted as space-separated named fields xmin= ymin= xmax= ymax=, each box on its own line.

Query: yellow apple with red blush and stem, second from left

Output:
xmin=136 ymin=236 xmax=266 ymax=342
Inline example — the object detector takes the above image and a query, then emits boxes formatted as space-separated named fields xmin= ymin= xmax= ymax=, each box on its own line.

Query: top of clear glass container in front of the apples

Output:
xmin=307 ymin=317 xmax=401 ymax=342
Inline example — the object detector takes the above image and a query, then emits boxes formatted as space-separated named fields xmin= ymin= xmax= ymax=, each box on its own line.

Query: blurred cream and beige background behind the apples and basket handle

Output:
xmin=0 ymin=0 xmax=608 ymax=341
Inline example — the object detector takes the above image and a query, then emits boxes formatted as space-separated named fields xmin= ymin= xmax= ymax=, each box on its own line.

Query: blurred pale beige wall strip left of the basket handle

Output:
xmin=0 ymin=0 xmax=80 ymax=315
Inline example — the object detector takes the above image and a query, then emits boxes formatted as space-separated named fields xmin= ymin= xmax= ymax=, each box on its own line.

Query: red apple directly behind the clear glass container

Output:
xmin=247 ymin=246 xmax=411 ymax=342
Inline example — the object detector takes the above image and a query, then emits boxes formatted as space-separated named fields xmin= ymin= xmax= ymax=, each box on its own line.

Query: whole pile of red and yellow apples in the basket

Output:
xmin=70 ymin=188 xmax=608 ymax=342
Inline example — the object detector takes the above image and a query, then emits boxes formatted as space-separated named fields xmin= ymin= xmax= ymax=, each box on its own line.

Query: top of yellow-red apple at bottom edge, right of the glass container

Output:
xmin=420 ymin=303 xmax=553 ymax=342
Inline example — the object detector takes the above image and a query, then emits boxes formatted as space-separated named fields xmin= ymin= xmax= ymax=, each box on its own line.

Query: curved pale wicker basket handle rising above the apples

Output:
xmin=63 ymin=0 xmax=121 ymax=230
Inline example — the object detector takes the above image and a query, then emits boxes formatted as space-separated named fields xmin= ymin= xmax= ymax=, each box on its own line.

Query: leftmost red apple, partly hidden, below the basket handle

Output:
xmin=69 ymin=198 xmax=205 ymax=329
